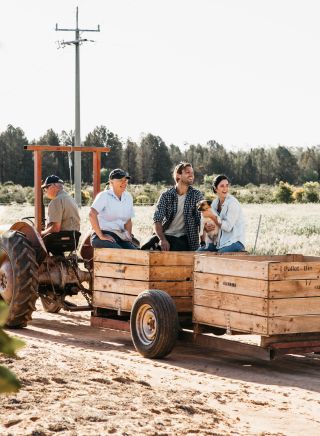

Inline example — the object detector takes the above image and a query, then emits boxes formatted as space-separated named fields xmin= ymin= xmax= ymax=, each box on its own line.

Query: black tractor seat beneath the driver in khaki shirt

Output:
xmin=43 ymin=230 xmax=81 ymax=256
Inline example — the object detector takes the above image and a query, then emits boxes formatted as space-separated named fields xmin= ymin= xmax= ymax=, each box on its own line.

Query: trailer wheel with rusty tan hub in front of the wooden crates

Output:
xmin=130 ymin=290 xmax=179 ymax=359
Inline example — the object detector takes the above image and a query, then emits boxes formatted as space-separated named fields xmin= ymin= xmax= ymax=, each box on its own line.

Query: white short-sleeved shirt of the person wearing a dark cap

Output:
xmin=91 ymin=188 xmax=134 ymax=232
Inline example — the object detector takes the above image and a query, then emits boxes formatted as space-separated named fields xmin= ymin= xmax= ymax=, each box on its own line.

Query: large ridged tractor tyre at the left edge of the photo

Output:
xmin=0 ymin=230 xmax=38 ymax=328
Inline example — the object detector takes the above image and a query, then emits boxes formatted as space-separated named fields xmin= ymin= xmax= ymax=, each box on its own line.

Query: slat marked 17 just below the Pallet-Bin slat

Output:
xmin=269 ymin=279 xmax=320 ymax=298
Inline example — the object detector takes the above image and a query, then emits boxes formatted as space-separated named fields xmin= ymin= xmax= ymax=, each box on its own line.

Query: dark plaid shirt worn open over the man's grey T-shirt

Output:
xmin=153 ymin=186 xmax=203 ymax=251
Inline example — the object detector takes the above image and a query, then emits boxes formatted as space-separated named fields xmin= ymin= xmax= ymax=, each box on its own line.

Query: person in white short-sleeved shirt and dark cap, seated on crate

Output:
xmin=89 ymin=168 xmax=136 ymax=249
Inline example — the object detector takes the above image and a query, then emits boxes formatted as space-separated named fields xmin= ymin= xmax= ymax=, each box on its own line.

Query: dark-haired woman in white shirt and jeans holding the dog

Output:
xmin=198 ymin=174 xmax=245 ymax=253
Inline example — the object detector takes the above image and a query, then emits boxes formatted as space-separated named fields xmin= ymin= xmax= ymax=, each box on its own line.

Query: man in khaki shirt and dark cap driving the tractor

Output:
xmin=41 ymin=174 xmax=80 ymax=236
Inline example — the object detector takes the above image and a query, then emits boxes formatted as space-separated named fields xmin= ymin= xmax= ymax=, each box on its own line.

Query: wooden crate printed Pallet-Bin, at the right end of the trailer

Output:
xmin=193 ymin=254 xmax=320 ymax=336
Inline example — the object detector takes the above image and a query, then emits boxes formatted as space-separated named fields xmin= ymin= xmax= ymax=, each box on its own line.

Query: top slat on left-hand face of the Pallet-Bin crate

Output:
xmin=194 ymin=254 xmax=268 ymax=280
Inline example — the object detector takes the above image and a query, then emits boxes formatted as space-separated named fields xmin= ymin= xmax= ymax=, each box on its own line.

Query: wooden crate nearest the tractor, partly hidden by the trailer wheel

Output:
xmin=93 ymin=248 xmax=194 ymax=313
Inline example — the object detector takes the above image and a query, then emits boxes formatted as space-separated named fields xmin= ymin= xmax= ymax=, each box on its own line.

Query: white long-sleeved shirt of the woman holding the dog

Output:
xmin=211 ymin=194 xmax=245 ymax=249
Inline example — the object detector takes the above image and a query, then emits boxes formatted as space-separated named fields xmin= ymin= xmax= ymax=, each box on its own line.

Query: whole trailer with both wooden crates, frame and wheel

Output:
xmin=91 ymin=249 xmax=320 ymax=359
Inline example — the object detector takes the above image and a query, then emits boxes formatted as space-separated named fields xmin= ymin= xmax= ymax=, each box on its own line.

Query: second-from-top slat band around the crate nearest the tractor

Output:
xmin=94 ymin=262 xmax=193 ymax=281
